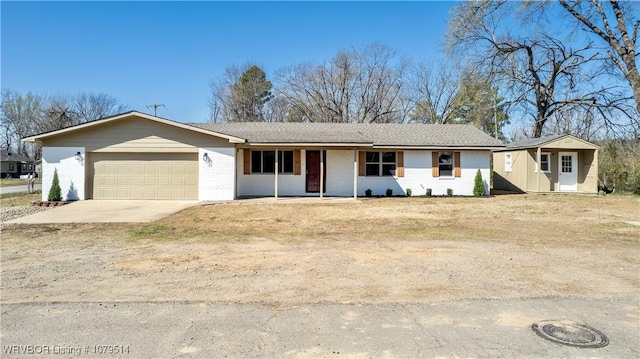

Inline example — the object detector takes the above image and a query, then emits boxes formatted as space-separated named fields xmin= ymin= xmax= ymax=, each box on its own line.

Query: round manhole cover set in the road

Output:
xmin=531 ymin=320 xmax=609 ymax=348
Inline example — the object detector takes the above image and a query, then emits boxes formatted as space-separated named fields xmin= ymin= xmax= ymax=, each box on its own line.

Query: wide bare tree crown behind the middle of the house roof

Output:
xmin=276 ymin=44 xmax=408 ymax=123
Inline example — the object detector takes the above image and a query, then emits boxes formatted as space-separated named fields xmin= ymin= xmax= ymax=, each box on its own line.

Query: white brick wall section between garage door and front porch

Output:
xmin=198 ymin=147 xmax=236 ymax=201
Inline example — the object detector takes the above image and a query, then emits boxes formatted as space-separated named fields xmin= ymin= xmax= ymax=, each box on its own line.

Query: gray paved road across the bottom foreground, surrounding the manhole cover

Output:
xmin=0 ymin=294 xmax=640 ymax=358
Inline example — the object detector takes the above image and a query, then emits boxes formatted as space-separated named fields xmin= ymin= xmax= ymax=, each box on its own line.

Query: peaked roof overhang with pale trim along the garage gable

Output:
xmin=22 ymin=111 xmax=246 ymax=143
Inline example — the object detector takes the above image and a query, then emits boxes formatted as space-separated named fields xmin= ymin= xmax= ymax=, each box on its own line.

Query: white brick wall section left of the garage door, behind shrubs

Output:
xmin=42 ymin=147 xmax=86 ymax=201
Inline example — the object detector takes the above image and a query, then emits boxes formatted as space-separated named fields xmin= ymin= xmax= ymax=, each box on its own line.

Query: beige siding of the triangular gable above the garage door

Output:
xmin=43 ymin=117 xmax=233 ymax=153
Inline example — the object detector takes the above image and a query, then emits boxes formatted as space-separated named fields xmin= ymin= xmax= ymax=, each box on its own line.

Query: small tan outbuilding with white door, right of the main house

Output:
xmin=493 ymin=135 xmax=599 ymax=193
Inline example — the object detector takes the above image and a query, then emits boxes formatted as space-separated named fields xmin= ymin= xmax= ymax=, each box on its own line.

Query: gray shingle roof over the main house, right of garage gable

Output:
xmin=189 ymin=122 xmax=504 ymax=147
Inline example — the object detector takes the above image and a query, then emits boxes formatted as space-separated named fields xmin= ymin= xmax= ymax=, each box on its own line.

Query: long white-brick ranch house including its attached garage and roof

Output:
xmin=23 ymin=111 xmax=504 ymax=201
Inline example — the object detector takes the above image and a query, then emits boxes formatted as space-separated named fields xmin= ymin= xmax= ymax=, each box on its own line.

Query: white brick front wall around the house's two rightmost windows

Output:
xmin=358 ymin=150 xmax=491 ymax=196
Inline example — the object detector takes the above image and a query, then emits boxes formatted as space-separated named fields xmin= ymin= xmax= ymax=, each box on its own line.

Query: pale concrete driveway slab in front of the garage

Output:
xmin=7 ymin=200 xmax=198 ymax=223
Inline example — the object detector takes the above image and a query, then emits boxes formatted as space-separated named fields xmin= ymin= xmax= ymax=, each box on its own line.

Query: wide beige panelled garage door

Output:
xmin=90 ymin=153 xmax=198 ymax=200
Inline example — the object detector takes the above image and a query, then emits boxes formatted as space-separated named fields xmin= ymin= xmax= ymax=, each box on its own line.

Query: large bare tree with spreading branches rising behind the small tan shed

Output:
xmin=447 ymin=1 xmax=637 ymax=137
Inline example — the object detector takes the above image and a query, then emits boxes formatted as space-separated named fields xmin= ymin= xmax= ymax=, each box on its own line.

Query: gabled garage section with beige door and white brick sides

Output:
xmin=25 ymin=111 xmax=245 ymax=201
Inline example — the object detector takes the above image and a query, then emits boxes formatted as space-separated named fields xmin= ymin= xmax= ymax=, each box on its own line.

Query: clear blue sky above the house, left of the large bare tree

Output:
xmin=0 ymin=1 xmax=455 ymax=122
